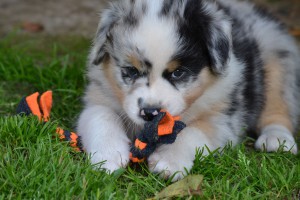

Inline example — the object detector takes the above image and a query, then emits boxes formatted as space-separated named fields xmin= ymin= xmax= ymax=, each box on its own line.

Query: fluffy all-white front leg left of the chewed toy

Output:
xmin=78 ymin=106 xmax=129 ymax=172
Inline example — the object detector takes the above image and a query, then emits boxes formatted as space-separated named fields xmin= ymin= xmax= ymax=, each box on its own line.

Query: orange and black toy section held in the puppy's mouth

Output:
xmin=130 ymin=110 xmax=186 ymax=163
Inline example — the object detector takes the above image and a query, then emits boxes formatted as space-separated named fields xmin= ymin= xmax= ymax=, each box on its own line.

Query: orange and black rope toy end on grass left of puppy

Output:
xmin=17 ymin=91 xmax=83 ymax=152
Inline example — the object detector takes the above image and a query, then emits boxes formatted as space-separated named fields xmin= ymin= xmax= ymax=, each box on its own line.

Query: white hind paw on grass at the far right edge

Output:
xmin=255 ymin=125 xmax=297 ymax=154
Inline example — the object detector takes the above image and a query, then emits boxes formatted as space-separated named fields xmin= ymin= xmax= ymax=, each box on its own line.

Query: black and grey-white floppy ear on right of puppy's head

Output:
xmin=178 ymin=0 xmax=232 ymax=74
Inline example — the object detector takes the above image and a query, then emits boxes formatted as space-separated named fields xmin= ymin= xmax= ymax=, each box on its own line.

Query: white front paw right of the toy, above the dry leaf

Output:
xmin=148 ymin=144 xmax=195 ymax=181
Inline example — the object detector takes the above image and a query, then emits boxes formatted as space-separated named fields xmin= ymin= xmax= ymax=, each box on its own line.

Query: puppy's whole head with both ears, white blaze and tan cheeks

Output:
xmin=90 ymin=0 xmax=231 ymax=125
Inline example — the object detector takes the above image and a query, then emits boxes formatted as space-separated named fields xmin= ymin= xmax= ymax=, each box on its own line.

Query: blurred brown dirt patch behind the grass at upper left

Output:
xmin=0 ymin=0 xmax=107 ymax=37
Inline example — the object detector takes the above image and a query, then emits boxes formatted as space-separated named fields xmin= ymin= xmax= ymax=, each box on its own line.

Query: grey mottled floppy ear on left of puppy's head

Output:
xmin=89 ymin=8 xmax=119 ymax=65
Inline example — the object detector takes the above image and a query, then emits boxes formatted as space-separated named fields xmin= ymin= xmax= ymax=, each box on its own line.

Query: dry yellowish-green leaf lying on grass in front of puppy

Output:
xmin=148 ymin=175 xmax=203 ymax=200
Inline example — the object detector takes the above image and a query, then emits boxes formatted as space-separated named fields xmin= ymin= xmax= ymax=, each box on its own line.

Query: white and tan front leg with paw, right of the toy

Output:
xmin=148 ymin=116 xmax=239 ymax=181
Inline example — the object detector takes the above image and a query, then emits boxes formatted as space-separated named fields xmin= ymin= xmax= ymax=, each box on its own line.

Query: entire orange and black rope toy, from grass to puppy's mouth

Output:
xmin=17 ymin=91 xmax=186 ymax=163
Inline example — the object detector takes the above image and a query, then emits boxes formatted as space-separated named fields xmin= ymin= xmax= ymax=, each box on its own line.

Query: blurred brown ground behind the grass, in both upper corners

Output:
xmin=0 ymin=0 xmax=300 ymax=38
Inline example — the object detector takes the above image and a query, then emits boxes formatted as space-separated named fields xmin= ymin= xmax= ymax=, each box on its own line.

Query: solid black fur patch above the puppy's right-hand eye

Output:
xmin=173 ymin=0 xmax=212 ymax=75
